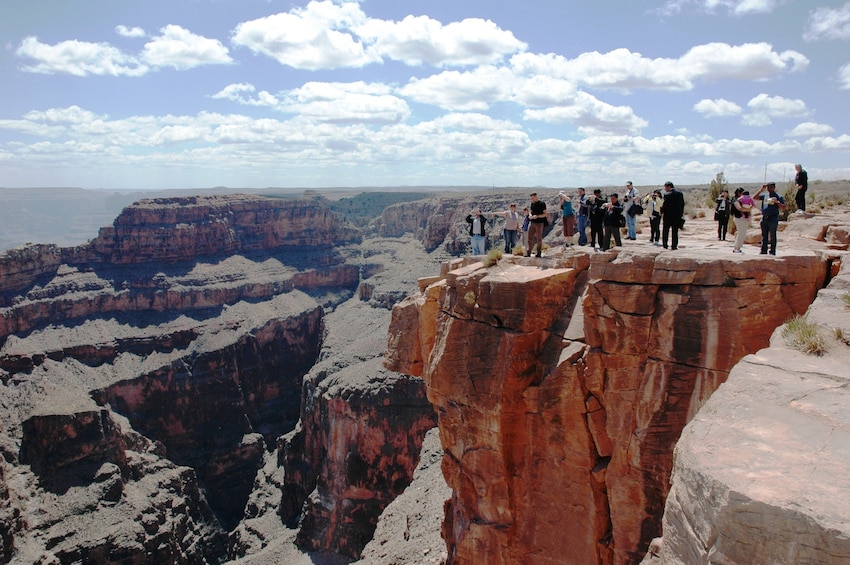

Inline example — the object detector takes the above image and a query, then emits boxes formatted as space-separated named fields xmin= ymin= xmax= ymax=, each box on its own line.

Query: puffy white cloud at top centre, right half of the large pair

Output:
xmin=356 ymin=16 xmax=527 ymax=67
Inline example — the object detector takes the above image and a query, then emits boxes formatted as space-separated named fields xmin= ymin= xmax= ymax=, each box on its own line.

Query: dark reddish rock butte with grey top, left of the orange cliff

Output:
xmin=281 ymin=358 xmax=436 ymax=558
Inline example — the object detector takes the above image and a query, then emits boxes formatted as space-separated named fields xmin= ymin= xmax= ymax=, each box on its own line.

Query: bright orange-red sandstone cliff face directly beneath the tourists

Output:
xmin=387 ymin=251 xmax=827 ymax=565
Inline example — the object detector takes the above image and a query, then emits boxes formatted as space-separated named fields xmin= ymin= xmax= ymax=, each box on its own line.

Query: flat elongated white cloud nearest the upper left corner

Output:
xmin=15 ymin=36 xmax=148 ymax=76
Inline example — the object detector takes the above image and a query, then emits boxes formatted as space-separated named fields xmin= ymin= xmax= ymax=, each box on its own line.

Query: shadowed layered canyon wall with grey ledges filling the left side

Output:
xmin=0 ymin=196 xmax=359 ymax=563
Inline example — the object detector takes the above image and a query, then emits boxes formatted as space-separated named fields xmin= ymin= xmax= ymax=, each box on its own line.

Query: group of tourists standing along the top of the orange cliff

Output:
xmin=466 ymin=165 xmax=808 ymax=257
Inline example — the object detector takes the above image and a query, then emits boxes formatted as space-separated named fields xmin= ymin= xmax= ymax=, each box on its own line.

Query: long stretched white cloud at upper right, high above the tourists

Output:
xmin=511 ymin=43 xmax=809 ymax=90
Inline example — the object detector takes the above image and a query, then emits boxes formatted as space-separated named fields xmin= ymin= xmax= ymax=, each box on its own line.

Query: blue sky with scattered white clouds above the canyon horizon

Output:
xmin=0 ymin=0 xmax=850 ymax=189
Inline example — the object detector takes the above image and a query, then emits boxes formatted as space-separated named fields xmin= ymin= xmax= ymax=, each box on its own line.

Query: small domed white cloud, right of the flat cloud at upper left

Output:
xmin=141 ymin=25 xmax=233 ymax=70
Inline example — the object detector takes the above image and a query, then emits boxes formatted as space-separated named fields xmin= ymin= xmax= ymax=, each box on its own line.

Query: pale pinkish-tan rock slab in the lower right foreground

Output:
xmin=646 ymin=258 xmax=850 ymax=565
